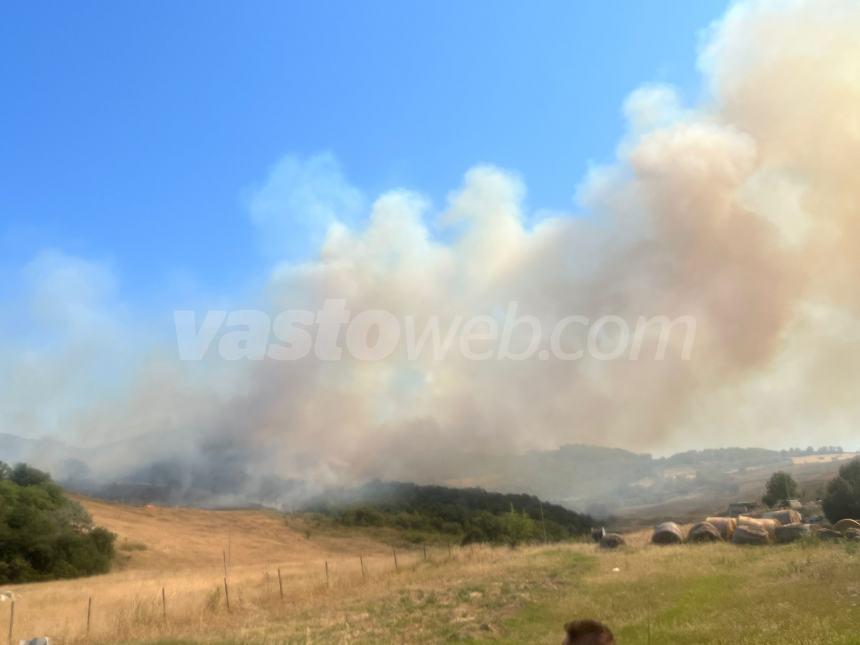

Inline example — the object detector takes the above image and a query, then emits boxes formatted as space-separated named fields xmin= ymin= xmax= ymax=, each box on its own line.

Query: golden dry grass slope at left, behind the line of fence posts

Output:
xmin=0 ymin=499 xmax=405 ymax=643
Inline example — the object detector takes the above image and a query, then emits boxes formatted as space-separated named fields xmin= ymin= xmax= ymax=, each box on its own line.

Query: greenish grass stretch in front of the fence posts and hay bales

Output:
xmin=117 ymin=543 xmax=860 ymax=645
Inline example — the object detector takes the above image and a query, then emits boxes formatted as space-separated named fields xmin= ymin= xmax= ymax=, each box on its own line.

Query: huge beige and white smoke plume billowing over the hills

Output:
xmin=0 ymin=0 xmax=860 ymax=504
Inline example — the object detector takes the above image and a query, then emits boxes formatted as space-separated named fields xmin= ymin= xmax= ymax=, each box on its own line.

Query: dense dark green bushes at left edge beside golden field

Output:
xmin=0 ymin=462 xmax=116 ymax=584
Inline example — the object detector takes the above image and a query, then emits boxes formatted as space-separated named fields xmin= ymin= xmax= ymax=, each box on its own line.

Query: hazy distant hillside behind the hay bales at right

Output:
xmin=445 ymin=445 xmax=854 ymax=517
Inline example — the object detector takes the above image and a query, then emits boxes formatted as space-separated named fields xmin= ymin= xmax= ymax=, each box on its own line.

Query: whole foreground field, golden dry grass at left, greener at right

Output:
xmin=0 ymin=501 xmax=860 ymax=645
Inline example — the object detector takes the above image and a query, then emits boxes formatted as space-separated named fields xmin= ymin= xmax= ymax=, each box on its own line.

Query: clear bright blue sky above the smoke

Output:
xmin=0 ymin=0 xmax=726 ymax=301
